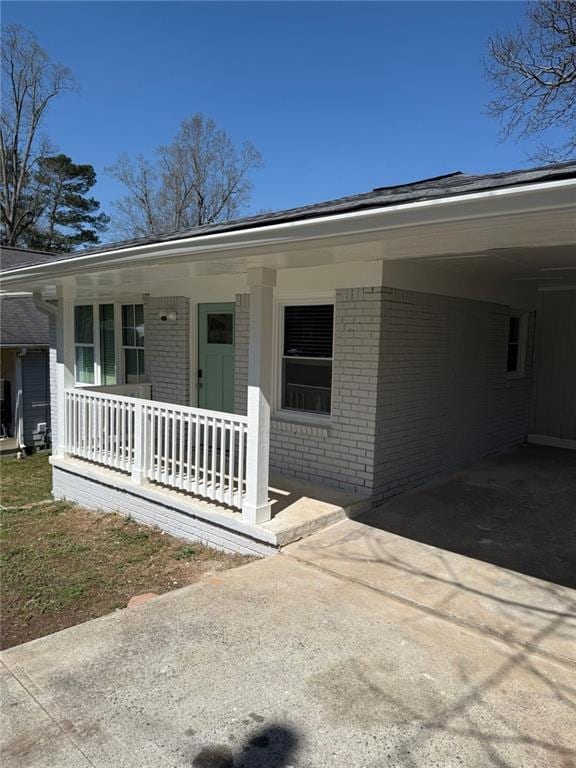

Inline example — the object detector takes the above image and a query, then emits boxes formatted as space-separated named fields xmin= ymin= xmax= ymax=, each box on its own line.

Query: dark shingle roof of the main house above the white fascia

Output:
xmin=2 ymin=160 xmax=576 ymax=268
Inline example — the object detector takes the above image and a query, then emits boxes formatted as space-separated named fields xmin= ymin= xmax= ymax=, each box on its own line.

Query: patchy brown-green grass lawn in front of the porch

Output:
xmin=0 ymin=456 xmax=249 ymax=648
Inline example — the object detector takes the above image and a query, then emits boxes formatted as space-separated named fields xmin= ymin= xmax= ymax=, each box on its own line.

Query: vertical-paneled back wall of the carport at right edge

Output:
xmin=530 ymin=290 xmax=576 ymax=440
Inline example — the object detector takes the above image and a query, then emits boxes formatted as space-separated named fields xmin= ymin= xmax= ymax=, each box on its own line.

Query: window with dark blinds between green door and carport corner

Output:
xmin=282 ymin=304 xmax=334 ymax=414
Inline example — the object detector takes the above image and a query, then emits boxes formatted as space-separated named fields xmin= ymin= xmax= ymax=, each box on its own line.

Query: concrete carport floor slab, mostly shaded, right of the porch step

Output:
xmin=283 ymin=445 xmax=576 ymax=663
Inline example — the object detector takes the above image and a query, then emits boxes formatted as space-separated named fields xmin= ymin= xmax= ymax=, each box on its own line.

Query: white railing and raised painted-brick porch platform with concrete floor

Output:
xmin=56 ymin=384 xmax=368 ymax=554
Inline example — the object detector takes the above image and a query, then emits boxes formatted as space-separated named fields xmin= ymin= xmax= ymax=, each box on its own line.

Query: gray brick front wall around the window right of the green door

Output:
xmin=236 ymin=288 xmax=382 ymax=493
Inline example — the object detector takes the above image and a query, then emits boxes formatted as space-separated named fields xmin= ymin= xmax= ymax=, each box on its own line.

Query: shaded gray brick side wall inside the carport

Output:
xmin=374 ymin=288 xmax=533 ymax=500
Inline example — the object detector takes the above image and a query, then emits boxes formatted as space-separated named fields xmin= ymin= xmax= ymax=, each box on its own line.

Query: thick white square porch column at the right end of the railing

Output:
xmin=242 ymin=267 xmax=276 ymax=525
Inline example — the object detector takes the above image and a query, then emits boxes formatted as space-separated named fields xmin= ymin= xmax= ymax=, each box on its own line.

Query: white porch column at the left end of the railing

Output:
xmin=52 ymin=283 xmax=76 ymax=457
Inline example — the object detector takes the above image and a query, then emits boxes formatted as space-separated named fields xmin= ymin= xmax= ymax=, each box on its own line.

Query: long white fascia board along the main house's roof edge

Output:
xmin=1 ymin=179 xmax=576 ymax=283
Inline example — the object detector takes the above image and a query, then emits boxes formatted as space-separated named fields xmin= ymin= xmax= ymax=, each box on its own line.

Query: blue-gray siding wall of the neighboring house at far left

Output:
xmin=22 ymin=349 xmax=50 ymax=447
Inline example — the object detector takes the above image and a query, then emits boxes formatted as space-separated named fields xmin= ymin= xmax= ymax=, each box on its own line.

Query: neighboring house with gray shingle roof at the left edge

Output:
xmin=0 ymin=246 xmax=62 ymax=455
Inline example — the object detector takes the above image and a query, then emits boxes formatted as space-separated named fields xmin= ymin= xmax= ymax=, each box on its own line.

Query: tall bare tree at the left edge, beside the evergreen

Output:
xmin=0 ymin=25 xmax=74 ymax=245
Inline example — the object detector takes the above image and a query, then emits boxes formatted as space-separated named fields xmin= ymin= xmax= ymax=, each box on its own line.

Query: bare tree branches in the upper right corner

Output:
xmin=486 ymin=0 xmax=576 ymax=160
